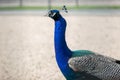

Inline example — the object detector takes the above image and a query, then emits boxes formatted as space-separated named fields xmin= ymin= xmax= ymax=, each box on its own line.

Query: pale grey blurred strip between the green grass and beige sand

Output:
xmin=0 ymin=9 xmax=120 ymax=16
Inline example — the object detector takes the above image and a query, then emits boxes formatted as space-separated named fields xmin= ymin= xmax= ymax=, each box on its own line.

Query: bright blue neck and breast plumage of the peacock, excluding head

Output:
xmin=54 ymin=17 xmax=73 ymax=78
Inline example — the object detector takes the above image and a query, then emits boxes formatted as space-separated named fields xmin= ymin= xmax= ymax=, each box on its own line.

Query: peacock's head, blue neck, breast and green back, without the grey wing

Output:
xmin=48 ymin=10 xmax=100 ymax=80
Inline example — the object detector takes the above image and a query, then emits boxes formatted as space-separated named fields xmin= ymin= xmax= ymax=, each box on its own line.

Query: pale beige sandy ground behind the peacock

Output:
xmin=0 ymin=15 xmax=120 ymax=80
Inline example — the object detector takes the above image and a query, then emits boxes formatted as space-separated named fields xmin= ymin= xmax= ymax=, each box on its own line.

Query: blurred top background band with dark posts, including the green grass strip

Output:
xmin=0 ymin=0 xmax=120 ymax=10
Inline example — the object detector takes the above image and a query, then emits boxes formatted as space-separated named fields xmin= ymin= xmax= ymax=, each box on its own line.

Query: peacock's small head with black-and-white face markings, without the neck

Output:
xmin=48 ymin=10 xmax=61 ymax=20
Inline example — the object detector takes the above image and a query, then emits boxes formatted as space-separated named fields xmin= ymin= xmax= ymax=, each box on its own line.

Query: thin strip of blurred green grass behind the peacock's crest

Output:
xmin=0 ymin=5 xmax=120 ymax=10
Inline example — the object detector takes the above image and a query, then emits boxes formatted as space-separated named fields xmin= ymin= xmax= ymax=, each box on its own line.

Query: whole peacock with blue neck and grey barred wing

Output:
xmin=48 ymin=6 xmax=120 ymax=80
